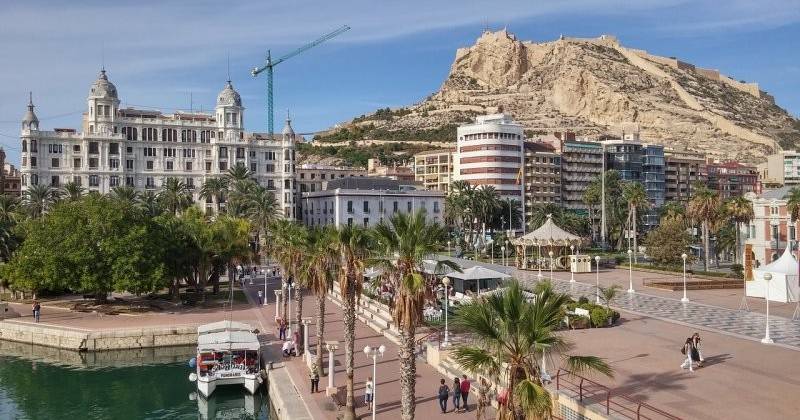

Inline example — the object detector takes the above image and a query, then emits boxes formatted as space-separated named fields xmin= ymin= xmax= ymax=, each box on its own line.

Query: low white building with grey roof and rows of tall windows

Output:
xmin=301 ymin=177 xmax=445 ymax=227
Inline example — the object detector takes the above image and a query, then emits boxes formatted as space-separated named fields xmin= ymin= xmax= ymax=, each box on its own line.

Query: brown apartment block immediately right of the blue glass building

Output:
xmin=664 ymin=149 xmax=708 ymax=204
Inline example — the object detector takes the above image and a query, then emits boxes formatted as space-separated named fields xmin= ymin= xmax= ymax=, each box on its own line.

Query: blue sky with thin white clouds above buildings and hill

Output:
xmin=0 ymin=0 xmax=800 ymax=164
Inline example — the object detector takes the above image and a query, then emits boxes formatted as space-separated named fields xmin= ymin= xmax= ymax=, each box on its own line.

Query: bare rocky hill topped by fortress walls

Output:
xmin=315 ymin=30 xmax=800 ymax=162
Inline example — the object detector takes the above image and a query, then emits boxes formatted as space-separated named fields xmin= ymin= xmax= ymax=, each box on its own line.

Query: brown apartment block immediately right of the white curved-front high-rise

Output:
xmin=523 ymin=141 xmax=561 ymax=213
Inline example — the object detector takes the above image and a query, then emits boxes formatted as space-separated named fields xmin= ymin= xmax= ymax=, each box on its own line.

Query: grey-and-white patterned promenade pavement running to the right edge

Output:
xmin=440 ymin=260 xmax=800 ymax=350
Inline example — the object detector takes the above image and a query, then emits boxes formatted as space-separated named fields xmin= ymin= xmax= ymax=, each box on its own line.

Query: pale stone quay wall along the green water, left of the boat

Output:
xmin=0 ymin=321 xmax=197 ymax=351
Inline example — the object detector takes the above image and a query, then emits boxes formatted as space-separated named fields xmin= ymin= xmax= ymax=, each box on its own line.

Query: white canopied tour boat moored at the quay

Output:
xmin=189 ymin=321 xmax=262 ymax=397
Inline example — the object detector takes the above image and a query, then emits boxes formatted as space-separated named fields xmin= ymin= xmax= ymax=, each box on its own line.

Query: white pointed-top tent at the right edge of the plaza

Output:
xmin=745 ymin=245 xmax=800 ymax=302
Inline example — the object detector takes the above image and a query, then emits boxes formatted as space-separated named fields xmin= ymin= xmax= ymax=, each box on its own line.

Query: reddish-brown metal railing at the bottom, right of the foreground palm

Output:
xmin=555 ymin=369 xmax=680 ymax=420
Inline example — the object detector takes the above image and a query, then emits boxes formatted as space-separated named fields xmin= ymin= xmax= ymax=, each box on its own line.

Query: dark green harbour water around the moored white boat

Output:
xmin=0 ymin=341 xmax=274 ymax=420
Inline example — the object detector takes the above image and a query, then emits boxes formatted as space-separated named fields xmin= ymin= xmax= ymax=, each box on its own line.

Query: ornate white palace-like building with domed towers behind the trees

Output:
xmin=20 ymin=70 xmax=297 ymax=217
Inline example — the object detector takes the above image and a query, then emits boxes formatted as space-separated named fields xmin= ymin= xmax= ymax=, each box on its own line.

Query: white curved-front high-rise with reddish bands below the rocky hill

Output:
xmin=453 ymin=114 xmax=525 ymax=201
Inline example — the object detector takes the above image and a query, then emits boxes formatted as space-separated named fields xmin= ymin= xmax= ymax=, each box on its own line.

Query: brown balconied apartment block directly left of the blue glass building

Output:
xmin=561 ymin=140 xmax=603 ymax=215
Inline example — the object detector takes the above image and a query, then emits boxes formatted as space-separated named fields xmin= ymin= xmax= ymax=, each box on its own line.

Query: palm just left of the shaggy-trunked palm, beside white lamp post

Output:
xmin=299 ymin=228 xmax=339 ymax=375
